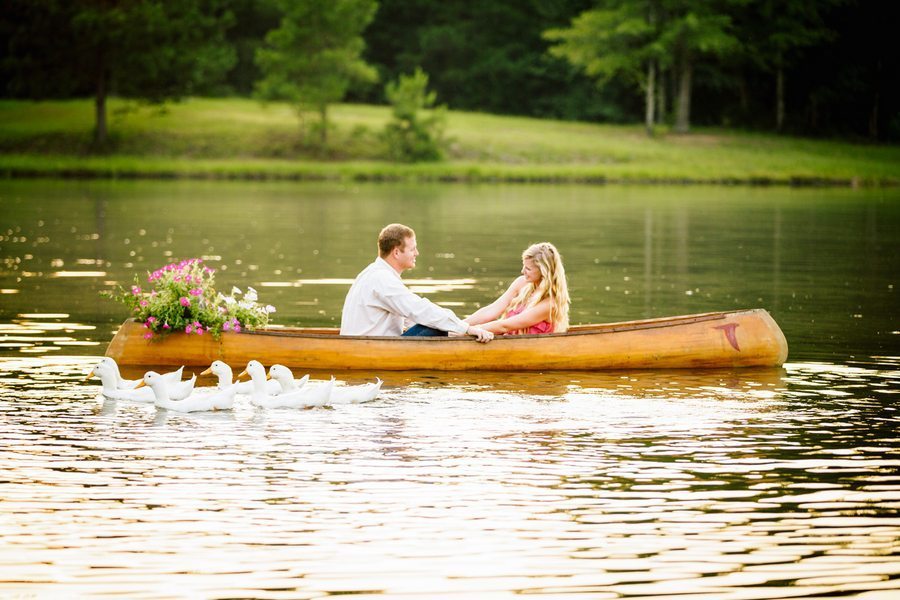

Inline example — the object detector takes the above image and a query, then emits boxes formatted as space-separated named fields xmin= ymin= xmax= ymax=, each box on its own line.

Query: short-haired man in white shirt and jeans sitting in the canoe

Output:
xmin=341 ymin=223 xmax=494 ymax=342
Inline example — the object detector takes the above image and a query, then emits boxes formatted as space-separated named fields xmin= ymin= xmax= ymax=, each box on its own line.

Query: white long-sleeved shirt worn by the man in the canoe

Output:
xmin=341 ymin=257 xmax=468 ymax=336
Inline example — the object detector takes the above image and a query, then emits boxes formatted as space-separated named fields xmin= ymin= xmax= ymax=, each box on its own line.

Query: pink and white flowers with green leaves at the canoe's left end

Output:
xmin=101 ymin=258 xmax=275 ymax=340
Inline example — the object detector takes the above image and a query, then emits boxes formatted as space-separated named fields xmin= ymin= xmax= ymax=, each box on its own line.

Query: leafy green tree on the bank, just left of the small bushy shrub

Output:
xmin=256 ymin=0 xmax=378 ymax=146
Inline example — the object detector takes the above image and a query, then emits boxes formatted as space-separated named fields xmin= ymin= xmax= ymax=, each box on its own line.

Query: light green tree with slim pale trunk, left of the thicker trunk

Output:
xmin=544 ymin=0 xmax=662 ymax=135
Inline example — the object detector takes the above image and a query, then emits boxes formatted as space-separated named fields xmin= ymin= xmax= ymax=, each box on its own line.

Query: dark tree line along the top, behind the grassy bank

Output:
xmin=0 ymin=0 xmax=900 ymax=141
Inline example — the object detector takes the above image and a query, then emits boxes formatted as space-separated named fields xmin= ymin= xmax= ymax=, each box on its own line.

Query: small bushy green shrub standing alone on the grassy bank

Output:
xmin=384 ymin=69 xmax=446 ymax=162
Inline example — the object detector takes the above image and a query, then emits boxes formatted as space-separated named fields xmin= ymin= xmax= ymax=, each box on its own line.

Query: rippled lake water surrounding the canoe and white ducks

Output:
xmin=0 ymin=181 xmax=900 ymax=600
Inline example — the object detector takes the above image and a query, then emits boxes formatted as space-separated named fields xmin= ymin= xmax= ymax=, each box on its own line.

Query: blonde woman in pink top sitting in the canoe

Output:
xmin=463 ymin=242 xmax=569 ymax=335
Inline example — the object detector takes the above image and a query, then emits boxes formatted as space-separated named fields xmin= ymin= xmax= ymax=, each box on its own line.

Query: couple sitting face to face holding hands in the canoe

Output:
xmin=341 ymin=223 xmax=569 ymax=342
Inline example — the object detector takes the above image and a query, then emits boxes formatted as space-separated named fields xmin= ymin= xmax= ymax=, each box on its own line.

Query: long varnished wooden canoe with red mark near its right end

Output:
xmin=106 ymin=309 xmax=788 ymax=371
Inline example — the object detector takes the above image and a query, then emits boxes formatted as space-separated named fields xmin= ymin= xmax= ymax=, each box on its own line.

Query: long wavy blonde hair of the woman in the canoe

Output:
xmin=503 ymin=242 xmax=569 ymax=333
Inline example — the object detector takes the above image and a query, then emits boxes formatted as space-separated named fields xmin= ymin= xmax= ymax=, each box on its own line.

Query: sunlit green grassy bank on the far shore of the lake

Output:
xmin=0 ymin=99 xmax=900 ymax=185
